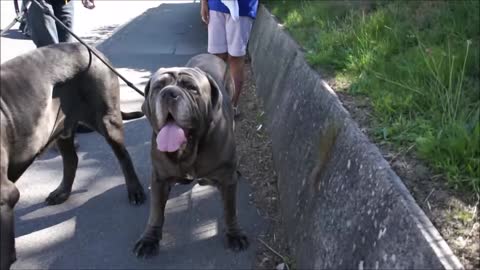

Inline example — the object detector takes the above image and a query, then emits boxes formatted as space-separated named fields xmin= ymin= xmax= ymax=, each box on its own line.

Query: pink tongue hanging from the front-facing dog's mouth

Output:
xmin=157 ymin=122 xmax=187 ymax=152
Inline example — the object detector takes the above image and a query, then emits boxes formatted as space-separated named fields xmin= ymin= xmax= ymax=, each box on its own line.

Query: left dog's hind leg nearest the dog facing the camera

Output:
xmin=100 ymin=112 xmax=145 ymax=204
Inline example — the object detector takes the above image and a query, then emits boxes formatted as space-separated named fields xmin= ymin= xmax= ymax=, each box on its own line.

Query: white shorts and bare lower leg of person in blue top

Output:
xmin=208 ymin=10 xmax=253 ymax=108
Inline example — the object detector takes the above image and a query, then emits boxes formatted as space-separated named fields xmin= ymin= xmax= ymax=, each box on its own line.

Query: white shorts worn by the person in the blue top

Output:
xmin=208 ymin=10 xmax=253 ymax=57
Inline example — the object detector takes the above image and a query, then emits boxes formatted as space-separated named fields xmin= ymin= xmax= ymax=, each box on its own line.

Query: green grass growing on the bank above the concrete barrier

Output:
xmin=264 ymin=0 xmax=480 ymax=193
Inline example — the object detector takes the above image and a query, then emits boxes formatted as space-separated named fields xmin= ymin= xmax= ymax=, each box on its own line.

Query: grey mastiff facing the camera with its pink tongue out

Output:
xmin=133 ymin=54 xmax=248 ymax=257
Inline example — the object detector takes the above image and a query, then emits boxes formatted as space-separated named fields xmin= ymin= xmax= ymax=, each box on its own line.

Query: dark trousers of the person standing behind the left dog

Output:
xmin=28 ymin=0 xmax=74 ymax=47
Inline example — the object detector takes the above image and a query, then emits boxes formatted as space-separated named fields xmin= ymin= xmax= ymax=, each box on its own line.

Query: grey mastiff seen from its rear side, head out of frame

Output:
xmin=0 ymin=43 xmax=145 ymax=270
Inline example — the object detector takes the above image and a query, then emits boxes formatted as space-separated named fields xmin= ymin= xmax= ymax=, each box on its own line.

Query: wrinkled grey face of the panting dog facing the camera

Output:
xmin=142 ymin=68 xmax=218 ymax=152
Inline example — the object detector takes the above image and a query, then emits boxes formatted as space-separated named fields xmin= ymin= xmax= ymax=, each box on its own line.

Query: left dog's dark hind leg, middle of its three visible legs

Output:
xmin=46 ymin=134 xmax=78 ymax=205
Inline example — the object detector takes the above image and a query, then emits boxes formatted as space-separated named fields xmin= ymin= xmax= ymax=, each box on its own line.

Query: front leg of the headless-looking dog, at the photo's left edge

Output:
xmin=0 ymin=147 xmax=20 ymax=270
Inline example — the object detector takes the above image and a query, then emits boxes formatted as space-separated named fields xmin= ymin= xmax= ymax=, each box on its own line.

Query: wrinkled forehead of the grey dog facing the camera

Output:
xmin=150 ymin=67 xmax=208 ymax=89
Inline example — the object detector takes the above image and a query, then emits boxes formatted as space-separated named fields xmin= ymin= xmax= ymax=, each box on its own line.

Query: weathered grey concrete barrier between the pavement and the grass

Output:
xmin=249 ymin=7 xmax=462 ymax=269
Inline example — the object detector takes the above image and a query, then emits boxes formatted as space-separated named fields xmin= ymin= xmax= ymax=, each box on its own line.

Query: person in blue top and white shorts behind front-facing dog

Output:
xmin=200 ymin=0 xmax=258 ymax=116
